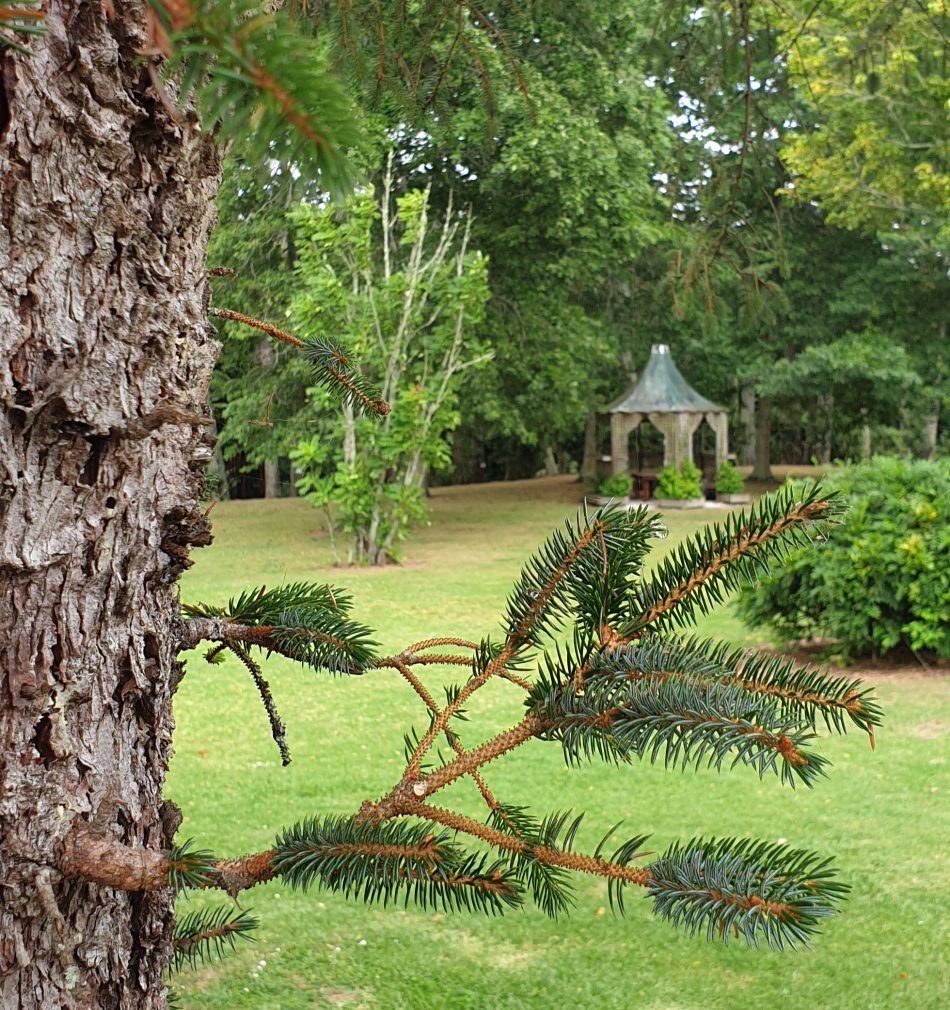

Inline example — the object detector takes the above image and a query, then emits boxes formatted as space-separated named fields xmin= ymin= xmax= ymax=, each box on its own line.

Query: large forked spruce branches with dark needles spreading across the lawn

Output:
xmin=172 ymin=486 xmax=880 ymax=961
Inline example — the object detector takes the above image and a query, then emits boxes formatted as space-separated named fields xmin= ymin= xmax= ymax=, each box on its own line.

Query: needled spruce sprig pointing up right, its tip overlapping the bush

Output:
xmin=622 ymin=484 xmax=841 ymax=639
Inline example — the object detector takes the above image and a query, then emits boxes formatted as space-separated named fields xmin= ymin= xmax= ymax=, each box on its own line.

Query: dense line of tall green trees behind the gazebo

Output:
xmin=212 ymin=0 xmax=950 ymax=494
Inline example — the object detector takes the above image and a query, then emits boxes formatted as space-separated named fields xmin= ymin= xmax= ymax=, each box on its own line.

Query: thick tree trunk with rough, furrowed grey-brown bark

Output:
xmin=0 ymin=0 xmax=218 ymax=1010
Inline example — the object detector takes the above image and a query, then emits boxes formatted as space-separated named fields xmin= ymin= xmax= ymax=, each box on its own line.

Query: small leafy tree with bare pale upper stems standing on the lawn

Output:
xmin=292 ymin=161 xmax=491 ymax=565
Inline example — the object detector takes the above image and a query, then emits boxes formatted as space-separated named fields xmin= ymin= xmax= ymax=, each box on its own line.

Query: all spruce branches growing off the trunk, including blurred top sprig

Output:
xmin=27 ymin=0 xmax=880 ymax=993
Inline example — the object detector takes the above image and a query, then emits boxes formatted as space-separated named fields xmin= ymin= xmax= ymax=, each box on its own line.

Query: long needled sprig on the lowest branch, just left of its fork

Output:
xmin=274 ymin=817 xmax=521 ymax=914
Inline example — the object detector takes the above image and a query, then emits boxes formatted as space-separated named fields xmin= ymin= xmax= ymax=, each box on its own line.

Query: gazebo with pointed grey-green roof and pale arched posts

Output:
xmin=584 ymin=343 xmax=729 ymax=492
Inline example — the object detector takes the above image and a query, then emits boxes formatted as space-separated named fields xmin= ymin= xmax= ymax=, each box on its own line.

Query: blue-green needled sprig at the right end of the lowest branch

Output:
xmin=646 ymin=838 xmax=849 ymax=950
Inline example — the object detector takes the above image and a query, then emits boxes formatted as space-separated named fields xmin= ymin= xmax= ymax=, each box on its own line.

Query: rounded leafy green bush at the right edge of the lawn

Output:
xmin=739 ymin=457 xmax=950 ymax=659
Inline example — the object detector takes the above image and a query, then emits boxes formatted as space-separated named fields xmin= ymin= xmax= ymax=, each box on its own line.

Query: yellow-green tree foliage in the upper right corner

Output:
xmin=777 ymin=0 xmax=950 ymax=248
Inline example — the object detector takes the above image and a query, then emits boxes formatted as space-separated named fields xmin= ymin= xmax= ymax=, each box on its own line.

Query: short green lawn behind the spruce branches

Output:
xmin=168 ymin=479 xmax=950 ymax=1010
